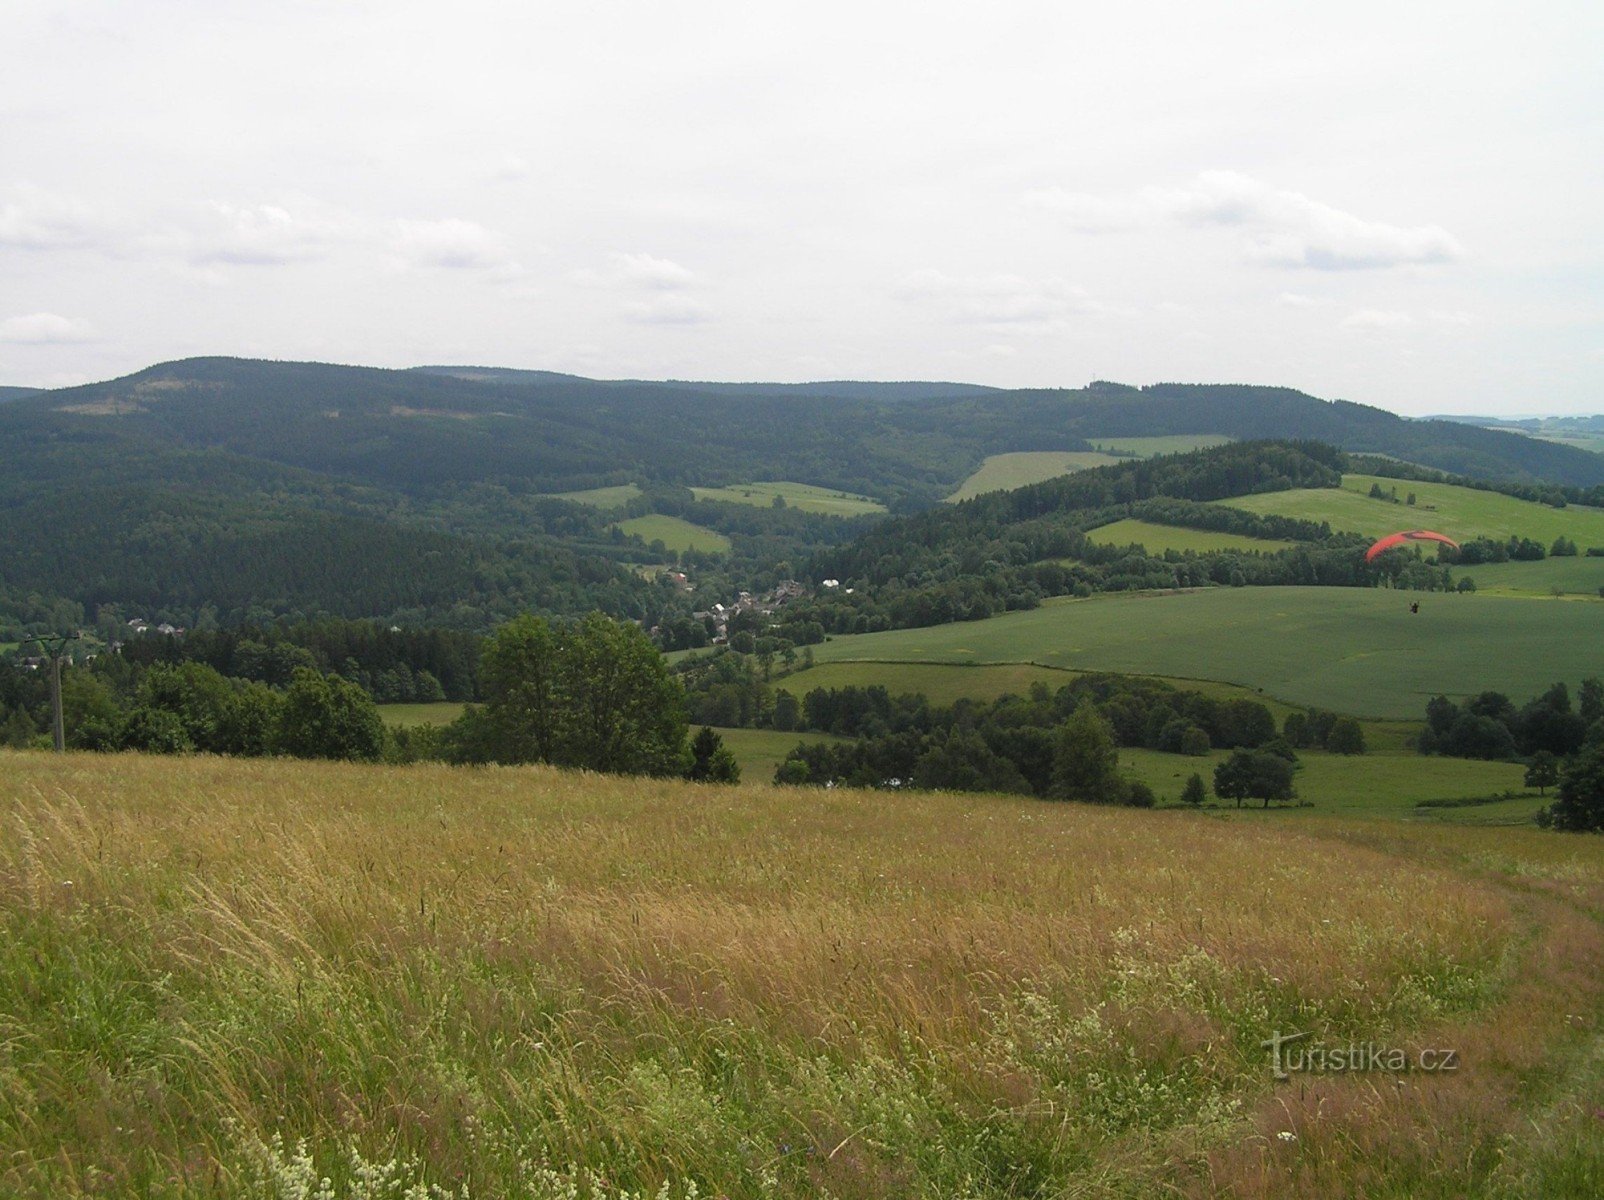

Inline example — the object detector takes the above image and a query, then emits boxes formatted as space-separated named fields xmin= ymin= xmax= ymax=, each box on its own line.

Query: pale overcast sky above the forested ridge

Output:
xmin=0 ymin=0 xmax=1604 ymax=416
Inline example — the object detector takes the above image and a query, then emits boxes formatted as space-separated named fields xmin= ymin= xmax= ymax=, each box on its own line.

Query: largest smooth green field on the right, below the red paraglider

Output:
xmin=815 ymin=587 xmax=1604 ymax=720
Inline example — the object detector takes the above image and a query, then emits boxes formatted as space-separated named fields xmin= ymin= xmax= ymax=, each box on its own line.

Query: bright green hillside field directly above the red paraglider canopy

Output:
xmin=1217 ymin=475 xmax=1604 ymax=549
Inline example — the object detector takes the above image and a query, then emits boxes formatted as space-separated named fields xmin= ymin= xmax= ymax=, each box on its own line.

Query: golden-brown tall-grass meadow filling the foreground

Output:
xmin=0 ymin=752 xmax=1604 ymax=1200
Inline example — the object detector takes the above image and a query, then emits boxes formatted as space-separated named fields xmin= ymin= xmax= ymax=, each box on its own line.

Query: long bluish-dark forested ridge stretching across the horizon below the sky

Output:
xmin=12 ymin=358 xmax=1604 ymax=497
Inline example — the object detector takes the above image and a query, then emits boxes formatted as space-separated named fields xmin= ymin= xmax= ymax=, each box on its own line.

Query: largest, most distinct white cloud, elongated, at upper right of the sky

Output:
xmin=1023 ymin=170 xmax=1464 ymax=271
